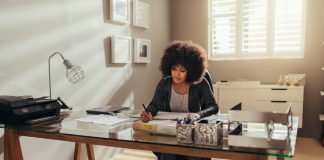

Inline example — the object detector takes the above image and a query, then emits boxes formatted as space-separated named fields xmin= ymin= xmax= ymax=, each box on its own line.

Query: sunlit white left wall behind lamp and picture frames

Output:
xmin=0 ymin=0 xmax=170 ymax=160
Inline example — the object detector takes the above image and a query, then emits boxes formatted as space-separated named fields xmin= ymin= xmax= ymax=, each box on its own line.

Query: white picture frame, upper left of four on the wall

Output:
xmin=110 ymin=0 xmax=130 ymax=23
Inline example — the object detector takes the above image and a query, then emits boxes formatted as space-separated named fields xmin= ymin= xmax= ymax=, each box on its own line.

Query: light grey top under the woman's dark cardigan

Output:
xmin=170 ymin=87 xmax=189 ymax=112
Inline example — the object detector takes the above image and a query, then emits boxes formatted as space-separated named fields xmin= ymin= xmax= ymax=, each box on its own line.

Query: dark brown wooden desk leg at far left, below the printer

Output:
xmin=4 ymin=128 xmax=24 ymax=160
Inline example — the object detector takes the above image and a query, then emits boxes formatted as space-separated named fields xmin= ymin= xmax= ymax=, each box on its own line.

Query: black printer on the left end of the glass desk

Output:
xmin=0 ymin=96 xmax=62 ymax=125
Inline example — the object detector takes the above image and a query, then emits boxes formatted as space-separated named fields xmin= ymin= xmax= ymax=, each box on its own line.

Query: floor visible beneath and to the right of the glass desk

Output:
xmin=111 ymin=138 xmax=324 ymax=160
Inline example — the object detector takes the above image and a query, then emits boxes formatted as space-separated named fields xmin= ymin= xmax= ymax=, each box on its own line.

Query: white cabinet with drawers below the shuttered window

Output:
xmin=214 ymin=81 xmax=304 ymax=128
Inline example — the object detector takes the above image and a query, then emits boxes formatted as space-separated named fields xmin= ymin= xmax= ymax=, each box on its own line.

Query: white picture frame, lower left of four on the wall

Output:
xmin=111 ymin=36 xmax=132 ymax=63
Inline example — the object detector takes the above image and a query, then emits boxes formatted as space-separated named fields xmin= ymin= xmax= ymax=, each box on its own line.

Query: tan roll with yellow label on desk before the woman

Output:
xmin=132 ymin=120 xmax=177 ymax=136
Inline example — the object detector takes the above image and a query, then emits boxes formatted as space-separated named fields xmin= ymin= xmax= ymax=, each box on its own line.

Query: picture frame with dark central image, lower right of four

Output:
xmin=134 ymin=38 xmax=151 ymax=63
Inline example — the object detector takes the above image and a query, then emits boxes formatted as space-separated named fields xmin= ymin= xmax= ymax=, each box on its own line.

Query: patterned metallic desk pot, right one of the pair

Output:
xmin=195 ymin=121 xmax=223 ymax=146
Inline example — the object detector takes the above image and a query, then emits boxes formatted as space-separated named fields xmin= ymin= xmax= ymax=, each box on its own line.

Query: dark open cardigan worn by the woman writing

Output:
xmin=147 ymin=76 xmax=218 ymax=118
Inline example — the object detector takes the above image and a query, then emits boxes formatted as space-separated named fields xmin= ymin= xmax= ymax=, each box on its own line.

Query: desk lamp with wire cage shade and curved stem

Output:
xmin=48 ymin=52 xmax=85 ymax=99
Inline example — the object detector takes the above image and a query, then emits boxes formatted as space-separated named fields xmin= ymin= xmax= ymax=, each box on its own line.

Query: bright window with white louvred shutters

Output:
xmin=209 ymin=0 xmax=306 ymax=60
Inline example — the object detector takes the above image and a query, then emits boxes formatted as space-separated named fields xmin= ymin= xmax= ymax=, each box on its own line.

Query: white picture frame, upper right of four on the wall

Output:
xmin=133 ymin=0 xmax=150 ymax=28
